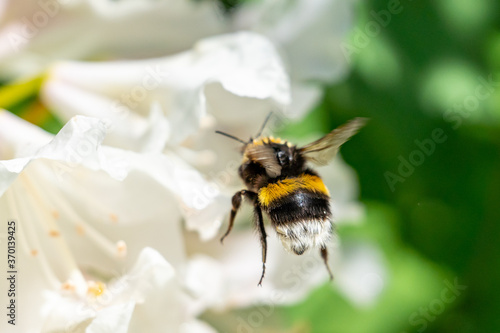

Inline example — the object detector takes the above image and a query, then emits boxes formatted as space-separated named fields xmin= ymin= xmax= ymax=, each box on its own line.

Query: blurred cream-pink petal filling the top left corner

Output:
xmin=0 ymin=0 xmax=224 ymax=78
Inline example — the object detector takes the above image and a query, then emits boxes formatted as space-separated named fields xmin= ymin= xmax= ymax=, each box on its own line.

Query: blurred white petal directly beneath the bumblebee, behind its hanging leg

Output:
xmin=182 ymin=228 xmax=338 ymax=312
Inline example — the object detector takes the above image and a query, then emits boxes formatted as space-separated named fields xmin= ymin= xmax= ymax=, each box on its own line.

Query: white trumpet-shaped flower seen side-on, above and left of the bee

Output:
xmin=42 ymin=33 xmax=290 ymax=151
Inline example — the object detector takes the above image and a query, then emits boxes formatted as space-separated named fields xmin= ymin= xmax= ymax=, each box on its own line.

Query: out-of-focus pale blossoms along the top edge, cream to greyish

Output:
xmin=0 ymin=0 xmax=352 ymax=118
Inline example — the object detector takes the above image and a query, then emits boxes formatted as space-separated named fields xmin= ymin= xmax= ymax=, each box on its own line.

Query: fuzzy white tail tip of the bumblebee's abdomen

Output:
xmin=276 ymin=219 xmax=332 ymax=255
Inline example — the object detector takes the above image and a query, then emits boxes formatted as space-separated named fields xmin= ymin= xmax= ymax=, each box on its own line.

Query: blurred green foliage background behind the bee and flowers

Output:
xmin=0 ymin=0 xmax=500 ymax=333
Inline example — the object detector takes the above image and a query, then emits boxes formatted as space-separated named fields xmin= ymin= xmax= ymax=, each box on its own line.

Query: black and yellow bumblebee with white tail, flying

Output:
xmin=216 ymin=114 xmax=367 ymax=286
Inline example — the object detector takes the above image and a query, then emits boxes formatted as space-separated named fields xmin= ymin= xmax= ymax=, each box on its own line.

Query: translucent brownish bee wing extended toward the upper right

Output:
xmin=299 ymin=118 xmax=368 ymax=165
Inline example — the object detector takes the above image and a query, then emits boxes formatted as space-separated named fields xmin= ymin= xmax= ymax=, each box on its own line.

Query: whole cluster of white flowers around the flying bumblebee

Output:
xmin=0 ymin=0 xmax=382 ymax=333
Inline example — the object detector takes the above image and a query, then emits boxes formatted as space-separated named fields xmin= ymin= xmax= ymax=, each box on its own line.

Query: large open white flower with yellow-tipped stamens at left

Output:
xmin=0 ymin=111 xmax=218 ymax=332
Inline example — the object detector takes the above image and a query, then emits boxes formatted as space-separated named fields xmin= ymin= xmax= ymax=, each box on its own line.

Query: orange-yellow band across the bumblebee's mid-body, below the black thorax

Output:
xmin=259 ymin=174 xmax=330 ymax=206
